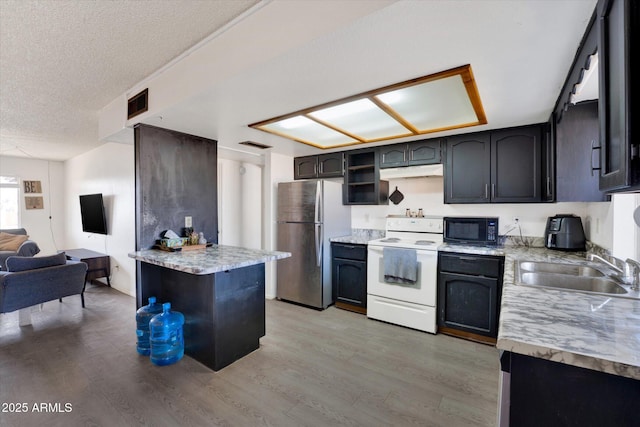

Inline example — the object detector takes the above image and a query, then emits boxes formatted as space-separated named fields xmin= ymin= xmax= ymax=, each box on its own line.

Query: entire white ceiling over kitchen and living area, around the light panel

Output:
xmin=0 ymin=0 xmax=596 ymax=164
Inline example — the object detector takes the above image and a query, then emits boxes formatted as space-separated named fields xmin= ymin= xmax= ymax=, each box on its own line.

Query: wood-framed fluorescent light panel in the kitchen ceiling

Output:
xmin=249 ymin=65 xmax=487 ymax=148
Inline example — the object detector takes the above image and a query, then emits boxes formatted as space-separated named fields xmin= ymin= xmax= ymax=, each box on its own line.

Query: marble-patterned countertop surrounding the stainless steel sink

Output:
xmin=482 ymin=247 xmax=640 ymax=379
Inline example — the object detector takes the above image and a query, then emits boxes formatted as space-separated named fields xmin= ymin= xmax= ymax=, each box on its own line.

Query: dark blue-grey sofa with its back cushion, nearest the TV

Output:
xmin=0 ymin=252 xmax=87 ymax=324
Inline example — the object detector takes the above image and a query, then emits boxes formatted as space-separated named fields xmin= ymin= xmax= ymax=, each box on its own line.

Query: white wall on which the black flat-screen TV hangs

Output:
xmin=65 ymin=143 xmax=136 ymax=296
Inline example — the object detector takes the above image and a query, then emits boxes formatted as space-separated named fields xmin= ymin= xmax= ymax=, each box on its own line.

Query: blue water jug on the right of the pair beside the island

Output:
xmin=149 ymin=302 xmax=184 ymax=366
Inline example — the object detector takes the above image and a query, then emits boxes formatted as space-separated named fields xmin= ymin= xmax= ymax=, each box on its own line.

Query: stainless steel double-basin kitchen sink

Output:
xmin=516 ymin=261 xmax=628 ymax=296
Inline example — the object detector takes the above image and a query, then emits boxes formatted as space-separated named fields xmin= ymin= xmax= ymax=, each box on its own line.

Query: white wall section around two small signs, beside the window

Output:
xmin=0 ymin=156 xmax=66 ymax=256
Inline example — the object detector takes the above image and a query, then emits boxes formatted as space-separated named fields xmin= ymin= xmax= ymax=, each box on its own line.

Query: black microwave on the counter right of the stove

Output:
xmin=444 ymin=216 xmax=498 ymax=245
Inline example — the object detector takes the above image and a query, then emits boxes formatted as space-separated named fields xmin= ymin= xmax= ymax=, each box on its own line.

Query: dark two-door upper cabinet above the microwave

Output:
xmin=444 ymin=125 xmax=543 ymax=203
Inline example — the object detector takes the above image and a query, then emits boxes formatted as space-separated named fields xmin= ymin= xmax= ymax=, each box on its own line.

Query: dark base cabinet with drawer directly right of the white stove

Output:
xmin=438 ymin=252 xmax=504 ymax=344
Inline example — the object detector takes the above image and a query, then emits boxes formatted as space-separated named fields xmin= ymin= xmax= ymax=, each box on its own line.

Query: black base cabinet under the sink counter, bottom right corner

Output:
xmin=499 ymin=351 xmax=640 ymax=427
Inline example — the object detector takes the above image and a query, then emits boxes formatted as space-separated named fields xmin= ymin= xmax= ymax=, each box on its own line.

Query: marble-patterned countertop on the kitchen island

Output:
xmin=129 ymin=245 xmax=291 ymax=274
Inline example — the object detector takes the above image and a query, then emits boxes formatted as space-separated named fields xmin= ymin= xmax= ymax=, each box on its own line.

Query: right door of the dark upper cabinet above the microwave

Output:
xmin=490 ymin=126 xmax=542 ymax=203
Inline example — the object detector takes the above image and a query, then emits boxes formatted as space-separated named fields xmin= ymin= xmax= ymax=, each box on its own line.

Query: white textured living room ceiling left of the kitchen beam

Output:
xmin=0 ymin=0 xmax=258 ymax=160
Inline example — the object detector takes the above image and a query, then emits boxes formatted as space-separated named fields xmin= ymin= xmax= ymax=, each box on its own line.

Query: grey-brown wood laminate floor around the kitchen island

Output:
xmin=0 ymin=286 xmax=499 ymax=427
